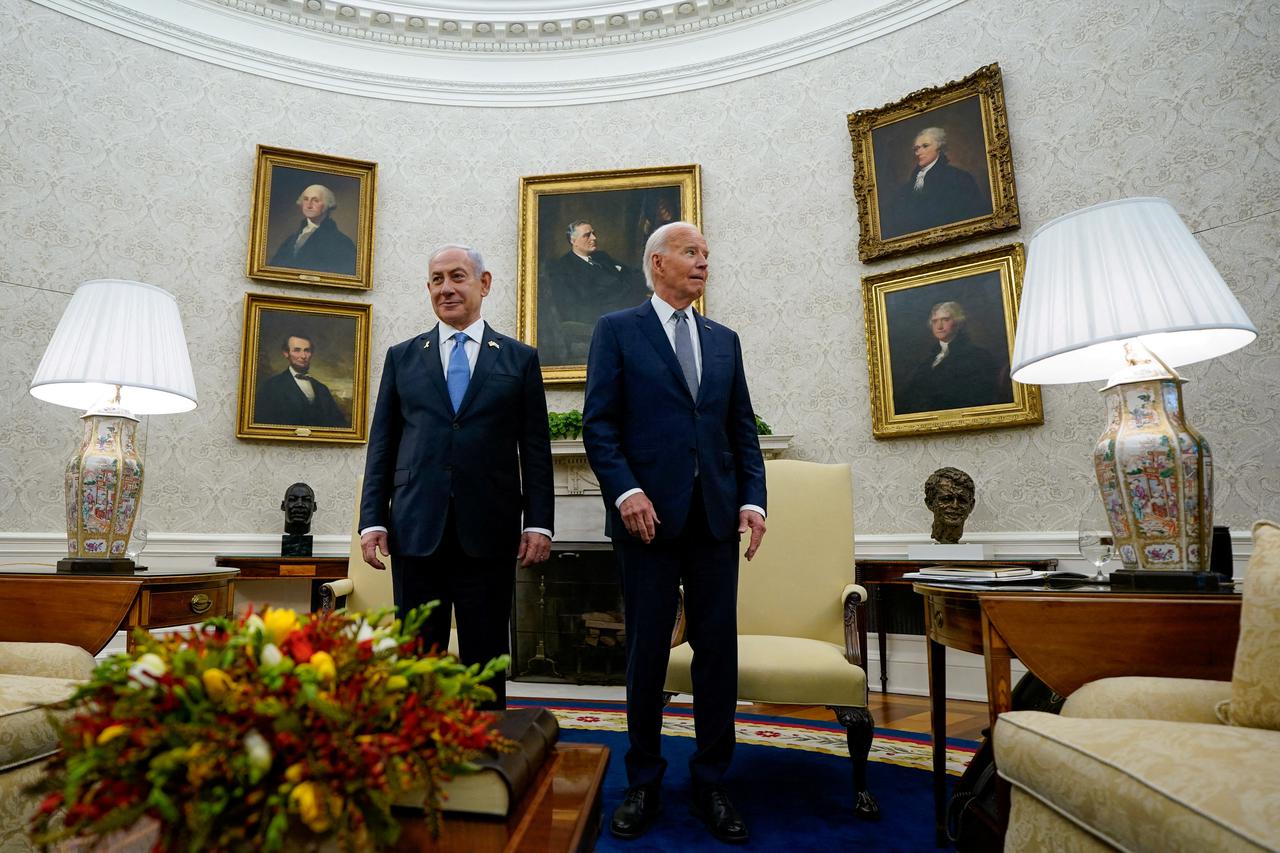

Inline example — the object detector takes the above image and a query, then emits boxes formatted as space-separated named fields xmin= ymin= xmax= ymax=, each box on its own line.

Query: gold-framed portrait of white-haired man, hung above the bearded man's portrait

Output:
xmin=247 ymin=145 xmax=378 ymax=291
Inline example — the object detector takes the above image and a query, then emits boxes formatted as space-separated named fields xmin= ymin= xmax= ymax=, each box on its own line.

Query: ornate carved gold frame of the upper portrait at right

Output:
xmin=849 ymin=63 xmax=1020 ymax=261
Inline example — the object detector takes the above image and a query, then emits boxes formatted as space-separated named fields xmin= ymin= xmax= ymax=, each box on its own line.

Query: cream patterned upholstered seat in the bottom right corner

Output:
xmin=995 ymin=521 xmax=1280 ymax=853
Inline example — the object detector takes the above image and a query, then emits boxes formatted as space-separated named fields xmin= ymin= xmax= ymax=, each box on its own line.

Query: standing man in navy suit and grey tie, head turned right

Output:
xmin=582 ymin=222 xmax=765 ymax=841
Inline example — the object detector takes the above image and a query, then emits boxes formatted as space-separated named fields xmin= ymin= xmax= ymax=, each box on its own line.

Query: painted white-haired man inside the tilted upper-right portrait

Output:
xmin=881 ymin=127 xmax=991 ymax=237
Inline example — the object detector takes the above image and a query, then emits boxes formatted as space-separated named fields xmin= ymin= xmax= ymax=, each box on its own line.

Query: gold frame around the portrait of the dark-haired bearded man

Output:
xmin=236 ymin=293 xmax=372 ymax=444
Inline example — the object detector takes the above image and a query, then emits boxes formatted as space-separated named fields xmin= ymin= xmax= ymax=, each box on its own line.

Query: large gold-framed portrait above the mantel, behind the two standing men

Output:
xmin=516 ymin=165 xmax=703 ymax=384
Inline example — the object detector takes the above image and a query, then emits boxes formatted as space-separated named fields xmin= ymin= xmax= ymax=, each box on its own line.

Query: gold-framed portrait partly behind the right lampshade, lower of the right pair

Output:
xmin=863 ymin=243 xmax=1044 ymax=438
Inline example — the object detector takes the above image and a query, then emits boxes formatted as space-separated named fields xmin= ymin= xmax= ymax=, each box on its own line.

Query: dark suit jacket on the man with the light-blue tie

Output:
xmin=360 ymin=323 xmax=554 ymax=558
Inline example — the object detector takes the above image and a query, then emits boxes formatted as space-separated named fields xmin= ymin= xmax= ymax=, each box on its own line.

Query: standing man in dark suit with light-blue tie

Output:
xmin=360 ymin=246 xmax=554 ymax=708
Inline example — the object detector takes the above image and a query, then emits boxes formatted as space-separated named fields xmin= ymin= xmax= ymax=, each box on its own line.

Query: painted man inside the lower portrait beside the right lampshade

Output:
xmin=893 ymin=302 xmax=1014 ymax=415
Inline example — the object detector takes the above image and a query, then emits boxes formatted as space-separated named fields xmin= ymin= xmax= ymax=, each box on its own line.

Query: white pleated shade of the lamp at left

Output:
xmin=31 ymin=279 xmax=196 ymax=415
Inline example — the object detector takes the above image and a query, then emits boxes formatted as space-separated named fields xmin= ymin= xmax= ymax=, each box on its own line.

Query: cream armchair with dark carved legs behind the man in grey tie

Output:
xmin=664 ymin=460 xmax=879 ymax=820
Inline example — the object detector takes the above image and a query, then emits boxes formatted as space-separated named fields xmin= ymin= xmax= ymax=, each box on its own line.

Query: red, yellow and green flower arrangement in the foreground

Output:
xmin=32 ymin=606 xmax=507 ymax=850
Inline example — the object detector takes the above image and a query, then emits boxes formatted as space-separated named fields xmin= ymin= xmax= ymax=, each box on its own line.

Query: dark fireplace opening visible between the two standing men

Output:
xmin=511 ymin=542 xmax=627 ymax=684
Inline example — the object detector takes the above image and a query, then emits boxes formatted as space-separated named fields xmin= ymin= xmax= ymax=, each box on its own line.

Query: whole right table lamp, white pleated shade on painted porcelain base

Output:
xmin=1012 ymin=199 xmax=1258 ymax=589
